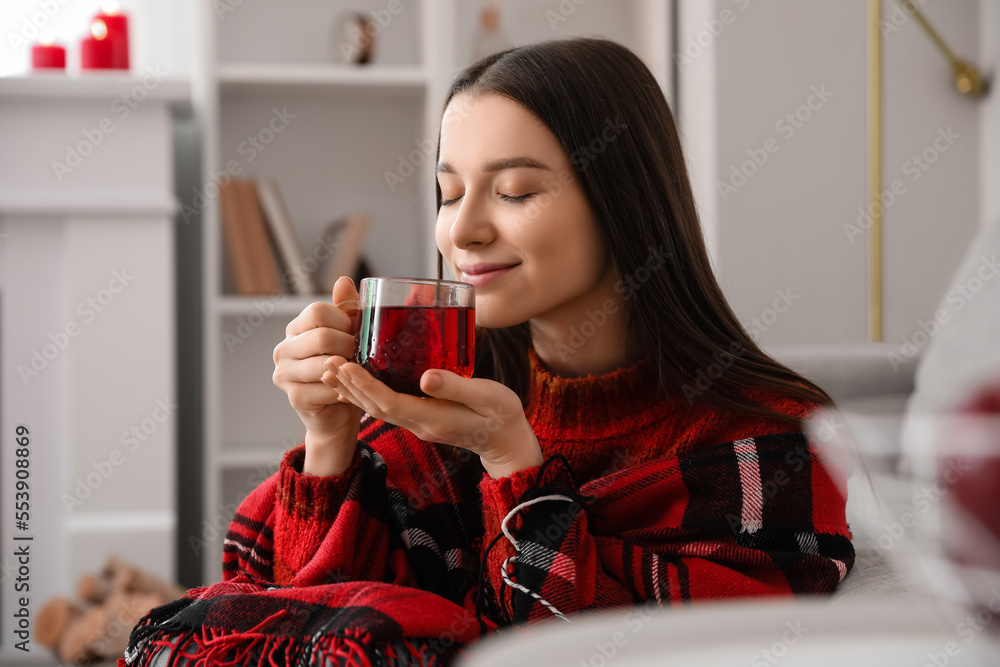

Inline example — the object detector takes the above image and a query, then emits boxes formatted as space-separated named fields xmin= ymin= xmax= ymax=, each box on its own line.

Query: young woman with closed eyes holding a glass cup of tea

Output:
xmin=125 ymin=39 xmax=854 ymax=664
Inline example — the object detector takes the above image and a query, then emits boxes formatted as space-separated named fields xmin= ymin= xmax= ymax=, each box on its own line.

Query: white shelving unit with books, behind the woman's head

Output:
xmin=197 ymin=0 xmax=671 ymax=582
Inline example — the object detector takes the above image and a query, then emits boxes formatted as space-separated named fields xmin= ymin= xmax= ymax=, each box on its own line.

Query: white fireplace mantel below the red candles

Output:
xmin=0 ymin=72 xmax=190 ymax=664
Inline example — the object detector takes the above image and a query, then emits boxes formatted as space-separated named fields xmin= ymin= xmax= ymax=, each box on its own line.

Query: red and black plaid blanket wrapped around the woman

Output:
xmin=119 ymin=420 xmax=854 ymax=667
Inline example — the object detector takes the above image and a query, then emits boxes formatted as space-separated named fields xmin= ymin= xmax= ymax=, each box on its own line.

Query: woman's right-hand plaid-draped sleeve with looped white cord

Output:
xmin=480 ymin=433 xmax=854 ymax=625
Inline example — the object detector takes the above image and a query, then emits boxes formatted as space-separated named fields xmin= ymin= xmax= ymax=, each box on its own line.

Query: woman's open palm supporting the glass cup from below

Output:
xmin=324 ymin=355 xmax=543 ymax=479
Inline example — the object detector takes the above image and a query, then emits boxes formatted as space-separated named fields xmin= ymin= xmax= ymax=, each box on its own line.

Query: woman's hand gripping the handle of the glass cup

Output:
xmin=272 ymin=276 xmax=361 ymax=475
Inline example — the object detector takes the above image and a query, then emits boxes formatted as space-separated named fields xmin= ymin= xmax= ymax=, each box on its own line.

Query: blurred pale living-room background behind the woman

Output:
xmin=0 ymin=0 xmax=1000 ymax=659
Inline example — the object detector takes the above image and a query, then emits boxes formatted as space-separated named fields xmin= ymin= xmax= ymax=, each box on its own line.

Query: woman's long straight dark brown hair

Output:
xmin=437 ymin=38 xmax=833 ymax=421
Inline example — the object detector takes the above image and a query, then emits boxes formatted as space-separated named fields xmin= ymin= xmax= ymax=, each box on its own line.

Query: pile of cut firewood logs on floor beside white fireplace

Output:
xmin=34 ymin=556 xmax=184 ymax=665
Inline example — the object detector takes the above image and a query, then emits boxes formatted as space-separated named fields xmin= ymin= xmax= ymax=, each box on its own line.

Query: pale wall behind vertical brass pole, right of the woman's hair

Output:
xmin=678 ymin=0 xmax=980 ymax=345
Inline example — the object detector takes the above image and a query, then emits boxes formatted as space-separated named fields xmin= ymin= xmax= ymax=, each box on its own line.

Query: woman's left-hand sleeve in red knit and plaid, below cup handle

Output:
xmin=223 ymin=415 xmax=481 ymax=601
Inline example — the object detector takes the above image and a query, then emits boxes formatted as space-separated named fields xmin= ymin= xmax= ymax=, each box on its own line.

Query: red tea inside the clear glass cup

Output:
xmin=354 ymin=306 xmax=476 ymax=396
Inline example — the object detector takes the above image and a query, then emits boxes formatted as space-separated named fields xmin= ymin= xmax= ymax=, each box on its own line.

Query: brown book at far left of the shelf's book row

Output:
xmin=219 ymin=179 xmax=283 ymax=296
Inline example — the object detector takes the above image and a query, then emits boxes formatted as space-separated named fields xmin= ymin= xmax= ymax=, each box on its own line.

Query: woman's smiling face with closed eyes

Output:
xmin=435 ymin=94 xmax=615 ymax=328
